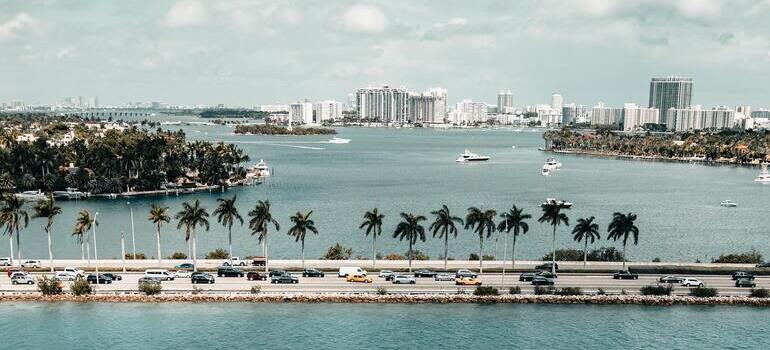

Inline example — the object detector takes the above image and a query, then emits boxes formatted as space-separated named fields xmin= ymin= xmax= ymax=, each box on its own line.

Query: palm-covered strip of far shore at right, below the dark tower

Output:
xmin=543 ymin=128 xmax=770 ymax=164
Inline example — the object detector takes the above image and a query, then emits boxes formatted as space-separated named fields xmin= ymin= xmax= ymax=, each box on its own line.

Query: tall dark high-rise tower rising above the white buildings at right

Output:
xmin=648 ymin=76 xmax=693 ymax=124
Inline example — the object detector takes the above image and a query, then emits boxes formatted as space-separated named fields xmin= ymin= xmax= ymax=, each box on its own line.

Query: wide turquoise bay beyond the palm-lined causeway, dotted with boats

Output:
xmin=7 ymin=125 xmax=770 ymax=261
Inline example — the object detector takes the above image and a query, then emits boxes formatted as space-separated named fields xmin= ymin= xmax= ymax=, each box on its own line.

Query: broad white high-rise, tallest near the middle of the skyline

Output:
xmin=356 ymin=85 xmax=409 ymax=123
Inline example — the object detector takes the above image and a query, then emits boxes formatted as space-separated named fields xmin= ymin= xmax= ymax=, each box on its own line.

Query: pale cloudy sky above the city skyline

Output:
xmin=0 ymin=0 xmax=770 ymax=107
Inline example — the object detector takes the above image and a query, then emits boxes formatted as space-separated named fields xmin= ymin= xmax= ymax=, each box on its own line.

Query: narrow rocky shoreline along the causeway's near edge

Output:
xmin=0 ymin=293 xmax=770 ymax=307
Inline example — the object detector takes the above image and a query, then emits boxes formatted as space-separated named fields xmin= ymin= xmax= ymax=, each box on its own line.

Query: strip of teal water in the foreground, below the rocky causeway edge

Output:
xmin=0 ymin=303 xmax=770 ymax=350
